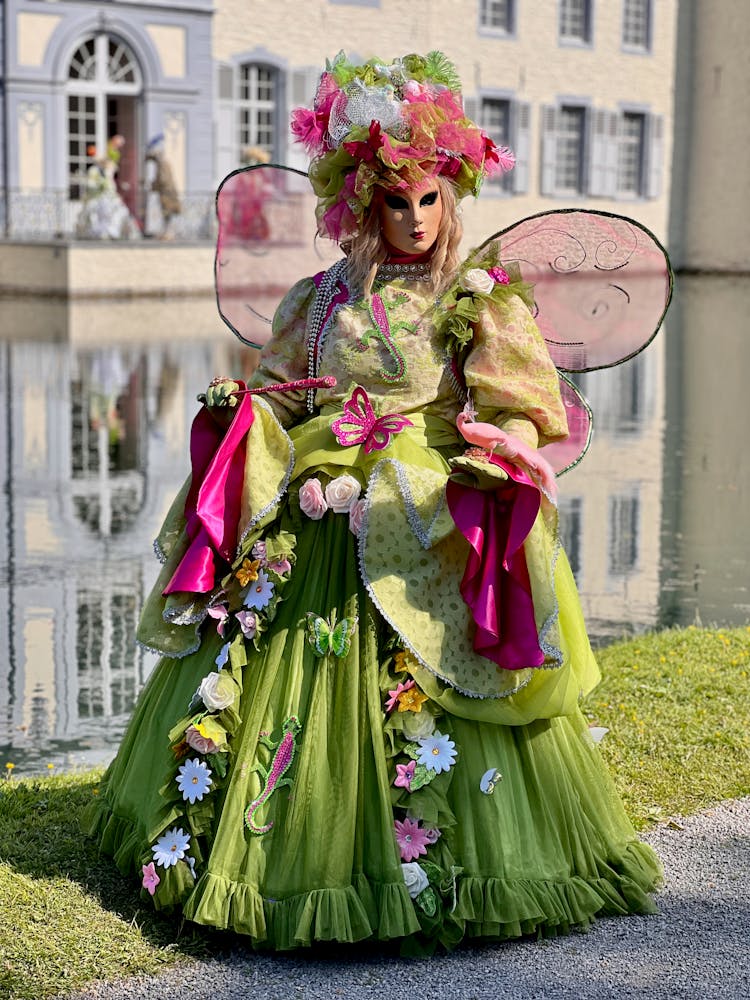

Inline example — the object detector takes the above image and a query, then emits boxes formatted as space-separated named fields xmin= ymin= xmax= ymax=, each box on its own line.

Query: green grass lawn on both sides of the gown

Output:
xmin=0 ymin=628 xmax=750 ymax=1000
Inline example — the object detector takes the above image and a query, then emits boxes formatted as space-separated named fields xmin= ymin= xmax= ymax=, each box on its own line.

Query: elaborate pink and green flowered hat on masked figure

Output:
xmin=291 ymin=51 xmax=515 ymax=241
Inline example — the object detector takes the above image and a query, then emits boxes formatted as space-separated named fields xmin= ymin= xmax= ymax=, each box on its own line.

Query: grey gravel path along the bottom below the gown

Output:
xmin=61 ymin=798 xmax=750 ymax=1000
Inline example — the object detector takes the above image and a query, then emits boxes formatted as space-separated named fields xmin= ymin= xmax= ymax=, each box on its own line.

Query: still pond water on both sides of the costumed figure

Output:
xmin=0 ymin=277 xmax=750 ymax=774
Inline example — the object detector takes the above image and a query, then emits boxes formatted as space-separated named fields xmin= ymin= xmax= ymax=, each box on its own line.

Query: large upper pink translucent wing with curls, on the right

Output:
xmin=485 ymin=209 xmax=673 ymax=372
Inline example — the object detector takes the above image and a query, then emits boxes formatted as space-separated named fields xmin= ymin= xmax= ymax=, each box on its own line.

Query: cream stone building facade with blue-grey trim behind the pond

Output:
xmin=0 ymin=0 xmax=678 ymax=238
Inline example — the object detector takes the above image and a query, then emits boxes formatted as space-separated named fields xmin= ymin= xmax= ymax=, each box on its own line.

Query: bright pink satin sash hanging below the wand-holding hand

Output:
xmin=162 ymin=383 xmax=253 ymax=597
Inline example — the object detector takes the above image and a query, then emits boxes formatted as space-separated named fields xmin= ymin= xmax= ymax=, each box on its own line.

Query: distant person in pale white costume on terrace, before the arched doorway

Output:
xmin=76 ymin=135 xmax=142 ymax=240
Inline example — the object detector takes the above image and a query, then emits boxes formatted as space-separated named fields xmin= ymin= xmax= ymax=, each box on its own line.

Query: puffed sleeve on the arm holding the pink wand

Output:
xmin=250 ymin=278 xmax=315 ymax=427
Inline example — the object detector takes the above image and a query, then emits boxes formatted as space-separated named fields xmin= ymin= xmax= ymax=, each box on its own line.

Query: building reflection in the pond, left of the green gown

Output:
xmin=0 ymin=328 xmax=248 ymax=773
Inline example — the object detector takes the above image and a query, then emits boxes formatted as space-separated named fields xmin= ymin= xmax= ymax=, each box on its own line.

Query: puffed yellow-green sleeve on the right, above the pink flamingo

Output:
xmin=464 ymin=295 xmax=568 ymax=448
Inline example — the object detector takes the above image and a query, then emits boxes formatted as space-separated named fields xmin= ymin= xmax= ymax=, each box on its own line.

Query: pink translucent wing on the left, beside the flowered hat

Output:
xmin=214 ymin=164 xmax=340 ymax=347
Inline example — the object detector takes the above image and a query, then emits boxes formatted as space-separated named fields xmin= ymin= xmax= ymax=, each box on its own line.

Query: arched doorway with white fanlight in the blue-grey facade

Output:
xmin=66 ymin=32 xmax=143 ymax=218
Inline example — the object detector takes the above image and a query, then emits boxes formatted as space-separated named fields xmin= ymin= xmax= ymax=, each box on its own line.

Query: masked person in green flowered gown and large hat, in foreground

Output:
xmin=87 ymin=52 xmax=661 ymax=953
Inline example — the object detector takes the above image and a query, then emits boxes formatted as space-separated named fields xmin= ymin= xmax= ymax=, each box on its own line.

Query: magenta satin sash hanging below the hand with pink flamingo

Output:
xmin=446 ymin=455 xmax=544 ymax=670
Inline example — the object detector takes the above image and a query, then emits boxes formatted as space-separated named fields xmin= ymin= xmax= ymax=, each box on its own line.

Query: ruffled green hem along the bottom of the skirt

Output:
xmin=82 ymin=801 xmax=662 ymax=954
